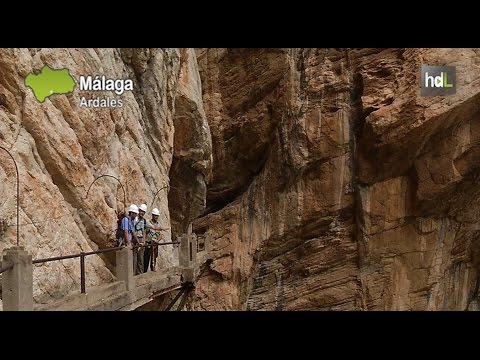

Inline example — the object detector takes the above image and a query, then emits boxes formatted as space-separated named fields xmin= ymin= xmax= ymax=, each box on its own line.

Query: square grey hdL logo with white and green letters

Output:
xmin=421 ymin=65 xmax=457 ymax=96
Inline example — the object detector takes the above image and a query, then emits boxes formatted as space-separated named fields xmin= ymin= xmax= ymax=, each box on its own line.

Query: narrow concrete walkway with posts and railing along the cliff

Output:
xmin=0 ymin=234 xmax=210 ymax=311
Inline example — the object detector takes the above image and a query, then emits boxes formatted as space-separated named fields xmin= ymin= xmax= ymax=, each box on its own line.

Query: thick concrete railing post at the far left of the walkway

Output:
xmin=2 ymin=246 xmax=33 ymax=311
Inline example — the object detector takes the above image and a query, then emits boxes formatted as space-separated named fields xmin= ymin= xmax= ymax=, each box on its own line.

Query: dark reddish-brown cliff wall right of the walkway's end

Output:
xmin=191 ymin=49 xmax=480 ymax=310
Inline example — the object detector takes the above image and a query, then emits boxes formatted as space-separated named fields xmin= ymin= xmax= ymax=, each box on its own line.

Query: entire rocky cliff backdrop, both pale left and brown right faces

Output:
xmin=0 ymin=49 xmax=480 ymax=310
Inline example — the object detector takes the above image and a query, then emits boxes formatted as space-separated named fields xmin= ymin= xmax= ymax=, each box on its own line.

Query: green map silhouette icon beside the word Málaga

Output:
xmin=25 ymin=65 xmax=75 ymax=102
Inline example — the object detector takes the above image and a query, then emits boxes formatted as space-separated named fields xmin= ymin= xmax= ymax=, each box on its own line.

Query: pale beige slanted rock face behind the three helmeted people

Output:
xmin=0 ymin=49 xmax=211 ymax=302
